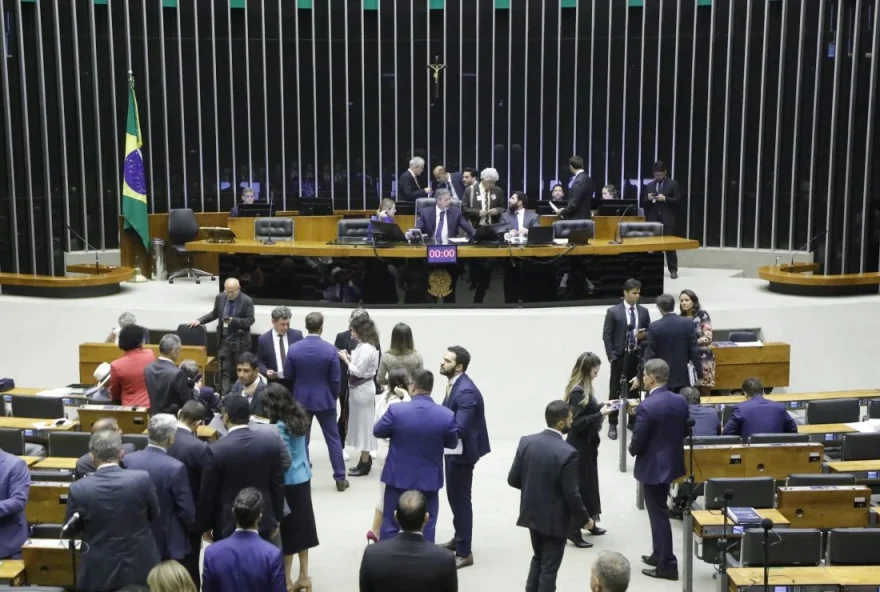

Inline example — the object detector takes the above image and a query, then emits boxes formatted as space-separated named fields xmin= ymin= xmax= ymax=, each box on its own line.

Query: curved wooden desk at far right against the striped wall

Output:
xmin=758 ymin=263 xmax=880 ymax=296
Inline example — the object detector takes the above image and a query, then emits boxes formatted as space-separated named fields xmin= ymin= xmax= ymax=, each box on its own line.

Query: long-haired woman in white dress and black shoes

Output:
xmin=339 ymin=316 xmax=379 ymax=477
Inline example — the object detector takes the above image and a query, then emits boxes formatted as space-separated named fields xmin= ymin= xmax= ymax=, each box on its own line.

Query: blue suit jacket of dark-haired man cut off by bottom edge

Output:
xmin=202 ymin=530 xmax=287 ymax=592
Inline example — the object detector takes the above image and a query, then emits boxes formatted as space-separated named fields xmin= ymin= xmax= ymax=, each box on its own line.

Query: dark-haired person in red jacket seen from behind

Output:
xmin=110 ymin=325 xmax=156 ymax=407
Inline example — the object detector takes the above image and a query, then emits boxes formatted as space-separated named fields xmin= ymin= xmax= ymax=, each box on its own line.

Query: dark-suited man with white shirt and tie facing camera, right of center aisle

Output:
xmin=602 ymin=279 xmax=651 ymax=440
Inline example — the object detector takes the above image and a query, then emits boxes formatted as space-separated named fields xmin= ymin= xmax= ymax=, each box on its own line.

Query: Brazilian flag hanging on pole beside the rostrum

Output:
xmin=122 ymin=74 xmax=150 ymax=251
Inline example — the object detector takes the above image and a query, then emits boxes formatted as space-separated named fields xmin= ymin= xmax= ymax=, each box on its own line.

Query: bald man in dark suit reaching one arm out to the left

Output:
xmin=189 ymin=278 xmax=254 ymax=395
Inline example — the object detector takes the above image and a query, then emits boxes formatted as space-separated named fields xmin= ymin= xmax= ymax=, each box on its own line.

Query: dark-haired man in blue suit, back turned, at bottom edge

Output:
xmin=202 ymin=487 xmax=287 ymax=592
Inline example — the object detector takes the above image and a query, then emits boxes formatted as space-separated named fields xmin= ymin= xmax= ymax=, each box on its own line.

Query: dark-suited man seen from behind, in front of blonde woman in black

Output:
xmin=507 ymin=401 xmax=596 ymax=592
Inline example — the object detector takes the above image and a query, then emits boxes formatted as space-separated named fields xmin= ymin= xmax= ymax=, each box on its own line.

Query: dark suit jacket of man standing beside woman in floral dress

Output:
xmin=645 ymin=313 xmax=703 ymax=390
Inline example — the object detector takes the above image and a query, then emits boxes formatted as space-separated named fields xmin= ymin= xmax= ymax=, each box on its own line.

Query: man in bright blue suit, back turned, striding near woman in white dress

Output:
xmin=284 ymin=312 xmax=348 ymax=491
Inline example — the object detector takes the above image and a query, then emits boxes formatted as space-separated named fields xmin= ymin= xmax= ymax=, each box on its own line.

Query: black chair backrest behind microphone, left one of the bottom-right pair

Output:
xmin=739 ymin=528 xmax=822 ymax=567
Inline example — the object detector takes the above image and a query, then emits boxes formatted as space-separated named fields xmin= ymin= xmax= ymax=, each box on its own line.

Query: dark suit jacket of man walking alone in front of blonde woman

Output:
xmin=507 ymin=429 xmax=590 ymax=539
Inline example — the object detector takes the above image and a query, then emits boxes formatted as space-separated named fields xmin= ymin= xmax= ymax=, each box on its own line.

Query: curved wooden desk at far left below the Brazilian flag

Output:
xmin=0 ymin=265 xmax=135 ymax=298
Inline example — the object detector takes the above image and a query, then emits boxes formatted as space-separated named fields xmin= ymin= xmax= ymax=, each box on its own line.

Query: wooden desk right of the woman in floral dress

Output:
xmin=712 ymin=342 xmax=791 ymax=390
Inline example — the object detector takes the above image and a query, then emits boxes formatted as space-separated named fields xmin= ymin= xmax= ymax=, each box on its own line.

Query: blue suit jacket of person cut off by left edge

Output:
xmin=0 ymin=450 xmax=31 ymax=559
